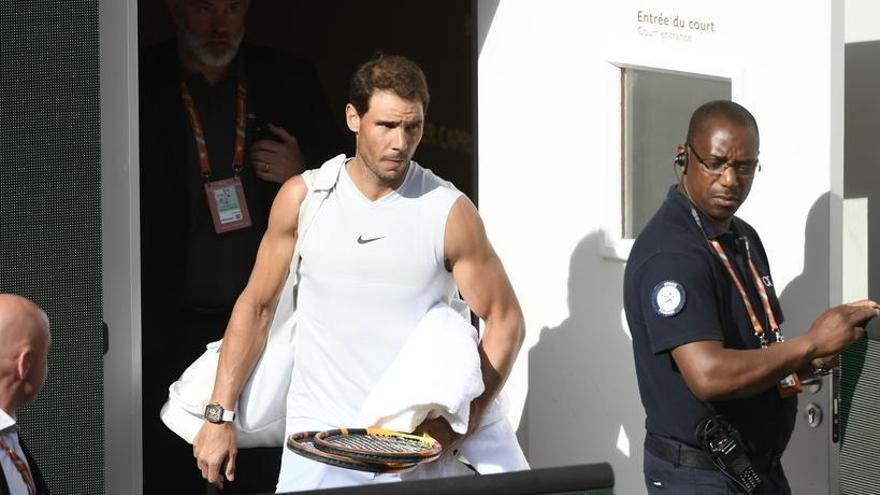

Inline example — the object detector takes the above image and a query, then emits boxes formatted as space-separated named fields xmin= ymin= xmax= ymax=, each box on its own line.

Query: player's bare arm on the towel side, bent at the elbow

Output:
xmin=444 ymin=197 xmax=525 ymax=431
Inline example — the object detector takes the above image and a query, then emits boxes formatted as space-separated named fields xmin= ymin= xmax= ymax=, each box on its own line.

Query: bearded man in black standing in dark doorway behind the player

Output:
xmin=139 ymin=0 xmax=342 ymax=493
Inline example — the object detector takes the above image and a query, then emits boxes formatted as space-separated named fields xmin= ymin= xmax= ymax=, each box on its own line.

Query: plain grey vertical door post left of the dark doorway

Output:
xmin=99 ymin=0 xmax=142 ymax=495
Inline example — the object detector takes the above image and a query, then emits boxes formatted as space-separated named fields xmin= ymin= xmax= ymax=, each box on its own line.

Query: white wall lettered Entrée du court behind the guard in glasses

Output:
xmin=478 ymin=0 xmax=843 ymax=493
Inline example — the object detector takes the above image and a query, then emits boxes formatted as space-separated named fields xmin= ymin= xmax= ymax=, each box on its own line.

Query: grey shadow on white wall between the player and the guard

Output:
xmin=517 ymin=231 xmax=645 ymax=494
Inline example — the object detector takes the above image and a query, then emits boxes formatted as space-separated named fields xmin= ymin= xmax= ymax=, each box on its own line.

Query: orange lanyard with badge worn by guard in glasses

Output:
xmin=691 ymin=206 xmax=801 ymax=397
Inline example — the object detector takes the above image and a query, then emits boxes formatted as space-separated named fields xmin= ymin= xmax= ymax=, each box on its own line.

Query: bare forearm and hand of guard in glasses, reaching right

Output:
xmin=672 ymin=301 xmax=877 ymax=401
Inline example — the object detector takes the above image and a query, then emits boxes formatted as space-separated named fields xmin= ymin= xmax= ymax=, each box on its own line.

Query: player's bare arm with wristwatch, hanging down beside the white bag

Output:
xmin=193 ymin=176 xmax=307 ymax=487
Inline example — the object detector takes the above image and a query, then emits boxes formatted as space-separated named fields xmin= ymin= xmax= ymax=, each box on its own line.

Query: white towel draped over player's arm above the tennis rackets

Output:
xmin=358 ymin=302 xmax=484 ymax=434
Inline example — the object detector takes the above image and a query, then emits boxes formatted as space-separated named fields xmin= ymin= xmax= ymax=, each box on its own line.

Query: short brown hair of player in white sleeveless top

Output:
xmin=348 ymin=52 xmax=431 ymax=115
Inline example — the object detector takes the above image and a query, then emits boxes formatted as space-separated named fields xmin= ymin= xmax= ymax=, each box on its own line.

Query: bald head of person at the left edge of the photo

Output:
xmin=0 ymin=294 xmax=51 ymax=412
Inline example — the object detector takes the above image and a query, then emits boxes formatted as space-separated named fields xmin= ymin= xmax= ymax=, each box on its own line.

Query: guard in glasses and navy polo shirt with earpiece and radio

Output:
xmin=624 ymin=101 xmax=880 ymax=494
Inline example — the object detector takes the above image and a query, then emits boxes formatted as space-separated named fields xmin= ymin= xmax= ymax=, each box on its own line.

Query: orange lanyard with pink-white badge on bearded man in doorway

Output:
xmin=180 ymin=79 xmax=251 ymax=234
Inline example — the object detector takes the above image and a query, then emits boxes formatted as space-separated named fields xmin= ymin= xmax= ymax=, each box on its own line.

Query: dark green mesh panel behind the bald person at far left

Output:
xmin=0 ymin=0 xmax=104 ymax=494
